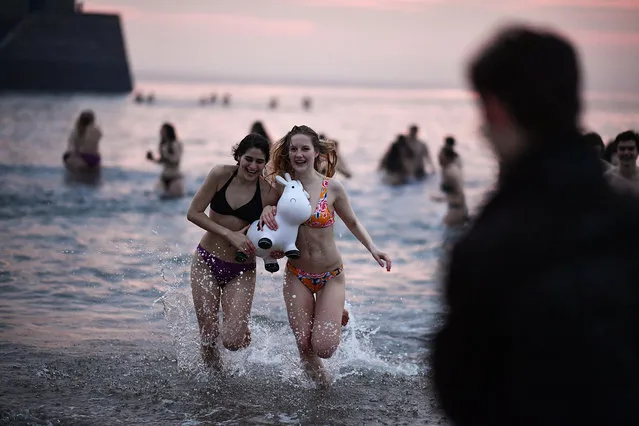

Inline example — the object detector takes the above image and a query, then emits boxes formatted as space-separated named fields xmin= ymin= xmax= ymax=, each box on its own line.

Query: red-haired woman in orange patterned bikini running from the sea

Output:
xmin=261 ymin=126 xmax=391 ymax=386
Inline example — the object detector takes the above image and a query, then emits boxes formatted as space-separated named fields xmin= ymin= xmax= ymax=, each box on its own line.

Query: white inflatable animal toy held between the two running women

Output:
xmin=236 ymin=173 xmax=312 ymax=272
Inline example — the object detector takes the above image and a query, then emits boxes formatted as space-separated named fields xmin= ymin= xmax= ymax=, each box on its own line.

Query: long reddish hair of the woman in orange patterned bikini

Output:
xmin=271 ymin=125 xmax=337 ymax=177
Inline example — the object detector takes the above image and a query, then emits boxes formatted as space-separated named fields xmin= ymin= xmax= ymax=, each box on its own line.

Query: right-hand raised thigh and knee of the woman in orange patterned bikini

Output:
xmin=311 ymin=272 xmax=346 ymax=358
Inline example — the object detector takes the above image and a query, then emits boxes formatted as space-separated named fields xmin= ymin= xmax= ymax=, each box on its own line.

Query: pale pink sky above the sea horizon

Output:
xmin=85 ymin=0 xmax=639 ymax=91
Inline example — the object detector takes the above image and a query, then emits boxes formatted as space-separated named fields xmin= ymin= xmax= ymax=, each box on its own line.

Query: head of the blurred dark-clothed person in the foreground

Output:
xmin=468 ymin=26 xmax=581 ymax=162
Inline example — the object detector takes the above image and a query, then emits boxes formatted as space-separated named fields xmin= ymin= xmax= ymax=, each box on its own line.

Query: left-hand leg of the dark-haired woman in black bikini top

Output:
xmin=191 ymin=252 xmax=221 ymax=370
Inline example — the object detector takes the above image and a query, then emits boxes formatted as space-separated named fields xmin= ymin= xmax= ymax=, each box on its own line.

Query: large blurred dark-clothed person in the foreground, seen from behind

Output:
xmin=431 ymin=27 xmax=639 ymax=426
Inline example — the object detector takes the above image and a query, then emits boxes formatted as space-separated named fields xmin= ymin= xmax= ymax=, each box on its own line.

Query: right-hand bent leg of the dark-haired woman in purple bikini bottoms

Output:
xmin=222 ymin=269 xmax=255 ymax=351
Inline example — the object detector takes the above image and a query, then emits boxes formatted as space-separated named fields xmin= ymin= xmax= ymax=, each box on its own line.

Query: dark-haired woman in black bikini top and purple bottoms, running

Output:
xmin=187 ymin=134 xmax=280 ymax=369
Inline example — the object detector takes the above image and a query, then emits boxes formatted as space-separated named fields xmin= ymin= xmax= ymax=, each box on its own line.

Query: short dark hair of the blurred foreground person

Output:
xmin=468 ymin=26 xmax=581 ymax=142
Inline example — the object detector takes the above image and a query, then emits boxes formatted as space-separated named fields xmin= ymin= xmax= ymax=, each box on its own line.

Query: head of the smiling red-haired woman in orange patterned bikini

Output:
xmin=273 ymin=125 xmax=337 ymax=177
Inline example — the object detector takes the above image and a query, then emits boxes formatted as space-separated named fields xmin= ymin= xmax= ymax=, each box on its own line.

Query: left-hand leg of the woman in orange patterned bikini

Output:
xmin=283 ymin=268 xmax=330 ymax=386
